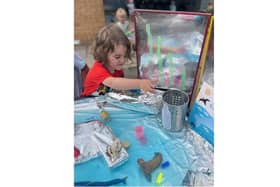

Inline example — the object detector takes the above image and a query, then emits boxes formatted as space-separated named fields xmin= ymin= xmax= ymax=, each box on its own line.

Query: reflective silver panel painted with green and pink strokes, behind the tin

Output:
xmin=134 ymin=10 xmax=210 ymax=93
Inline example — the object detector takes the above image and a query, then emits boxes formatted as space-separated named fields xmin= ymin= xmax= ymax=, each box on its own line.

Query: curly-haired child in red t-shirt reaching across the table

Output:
xmin=81 ymin=24 xmax=155 ymax=96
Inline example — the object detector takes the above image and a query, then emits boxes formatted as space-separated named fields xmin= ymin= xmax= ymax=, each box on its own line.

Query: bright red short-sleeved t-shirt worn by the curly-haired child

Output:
xmin=81 ymin=61 xmax=124 ymax=96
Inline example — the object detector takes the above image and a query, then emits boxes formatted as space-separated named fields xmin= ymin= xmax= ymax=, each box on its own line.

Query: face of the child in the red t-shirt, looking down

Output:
xmin=108 ymin=45 xmax=127 ymax=70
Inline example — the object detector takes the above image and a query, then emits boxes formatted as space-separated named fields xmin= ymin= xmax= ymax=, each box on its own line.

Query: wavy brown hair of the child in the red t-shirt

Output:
xmin=91 ymin=24 xmax=131 ymax=64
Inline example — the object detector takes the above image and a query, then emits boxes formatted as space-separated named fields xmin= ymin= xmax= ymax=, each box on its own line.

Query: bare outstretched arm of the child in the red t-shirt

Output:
xmin=103 ymin=77 xmax=155 ymax=93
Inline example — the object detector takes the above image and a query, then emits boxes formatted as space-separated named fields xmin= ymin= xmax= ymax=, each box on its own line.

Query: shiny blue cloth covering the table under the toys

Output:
xmin=75 ymin=98 xmax=213 ymax=186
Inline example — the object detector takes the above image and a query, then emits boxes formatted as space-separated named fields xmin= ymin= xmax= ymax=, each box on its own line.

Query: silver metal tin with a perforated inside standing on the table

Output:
xmin=161 ymin=89 xmax=189 ymax=131
